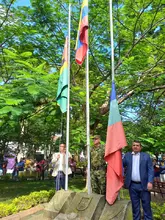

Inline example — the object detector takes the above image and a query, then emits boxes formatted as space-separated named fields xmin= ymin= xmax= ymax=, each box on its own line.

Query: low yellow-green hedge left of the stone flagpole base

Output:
xmin=0 ymin=190 xmax=55 ymax=218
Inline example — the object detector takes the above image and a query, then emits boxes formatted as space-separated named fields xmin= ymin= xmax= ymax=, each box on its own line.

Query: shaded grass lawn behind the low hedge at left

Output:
xmin=0 ymin=176 xmax=85 ymax=203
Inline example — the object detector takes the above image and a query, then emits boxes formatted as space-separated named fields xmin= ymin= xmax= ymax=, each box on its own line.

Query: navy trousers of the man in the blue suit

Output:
xmin=129 ymin=183 xmax=153 ymax=220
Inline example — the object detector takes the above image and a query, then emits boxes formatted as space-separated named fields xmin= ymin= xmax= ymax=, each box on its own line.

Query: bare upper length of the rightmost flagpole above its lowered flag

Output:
xmin=109 ymin=0 xmax=115 ymax=81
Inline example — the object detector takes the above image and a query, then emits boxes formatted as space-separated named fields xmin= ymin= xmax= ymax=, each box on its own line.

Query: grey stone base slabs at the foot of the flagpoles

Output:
xmin=43 ymin=191 xmax=132 ymax=220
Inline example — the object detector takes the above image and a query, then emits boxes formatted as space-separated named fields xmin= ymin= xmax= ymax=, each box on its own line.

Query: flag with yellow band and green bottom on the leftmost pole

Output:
xmin=56 ymin=37 xmax=68 ymax=113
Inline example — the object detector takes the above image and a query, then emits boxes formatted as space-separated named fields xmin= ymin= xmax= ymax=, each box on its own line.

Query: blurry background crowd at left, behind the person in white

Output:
xmin=0 ymin=154 xmax=76 ymax=181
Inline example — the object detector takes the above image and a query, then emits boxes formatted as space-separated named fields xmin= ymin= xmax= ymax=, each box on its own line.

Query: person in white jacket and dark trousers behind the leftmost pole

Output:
xmin=52 ymin=144 xmax=72 ymax=191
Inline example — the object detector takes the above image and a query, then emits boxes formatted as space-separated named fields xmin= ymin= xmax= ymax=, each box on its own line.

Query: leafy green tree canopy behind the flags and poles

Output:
xmin=0 ymin=0 xmax=165 ymax=153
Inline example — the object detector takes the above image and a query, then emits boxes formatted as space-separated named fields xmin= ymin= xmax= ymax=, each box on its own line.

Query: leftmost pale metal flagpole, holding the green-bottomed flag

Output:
xmin=65 ymin=3 xmax=71 ymax=190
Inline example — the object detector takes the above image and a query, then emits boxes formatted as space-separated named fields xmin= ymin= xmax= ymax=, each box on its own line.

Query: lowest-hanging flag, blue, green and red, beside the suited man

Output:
xmin=105 ymin=81 xmax=127 ymax=205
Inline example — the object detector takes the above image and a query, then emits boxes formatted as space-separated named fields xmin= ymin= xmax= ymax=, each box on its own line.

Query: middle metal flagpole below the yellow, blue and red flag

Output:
xmin=86 ymin=0 xmax=91 ymax=195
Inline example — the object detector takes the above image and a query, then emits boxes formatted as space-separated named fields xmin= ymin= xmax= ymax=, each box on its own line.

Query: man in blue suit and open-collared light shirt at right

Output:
xmin=123 ymin=141 xmax=154 ymax=220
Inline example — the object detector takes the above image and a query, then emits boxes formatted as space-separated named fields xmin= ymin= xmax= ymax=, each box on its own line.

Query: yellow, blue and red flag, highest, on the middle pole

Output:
xmin=76 ymin=0 xmax=88 ymax=65
